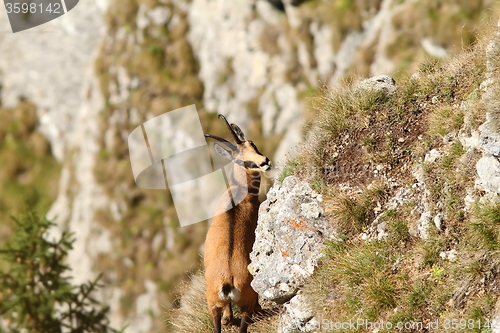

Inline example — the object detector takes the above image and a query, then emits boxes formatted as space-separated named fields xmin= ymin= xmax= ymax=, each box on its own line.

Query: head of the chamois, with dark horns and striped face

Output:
xmin=205 ymin=114 xmax=271 ymax=172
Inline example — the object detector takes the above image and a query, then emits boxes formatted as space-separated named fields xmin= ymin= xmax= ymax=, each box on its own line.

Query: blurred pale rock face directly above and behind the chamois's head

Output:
xmin=188 ymin=0 xmax=304 ymax=165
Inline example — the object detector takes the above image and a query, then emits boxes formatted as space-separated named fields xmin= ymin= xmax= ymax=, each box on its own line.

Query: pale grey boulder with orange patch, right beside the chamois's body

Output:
xmin=249 ymin=176 xmax=335 ymax=303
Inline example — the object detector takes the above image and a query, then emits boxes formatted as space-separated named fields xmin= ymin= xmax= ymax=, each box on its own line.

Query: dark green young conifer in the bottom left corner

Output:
xmin=0 ymin=211 xmax=117 ymax=333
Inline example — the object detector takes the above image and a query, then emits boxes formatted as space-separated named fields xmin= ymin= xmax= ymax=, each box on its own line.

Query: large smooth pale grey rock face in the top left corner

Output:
xmin=0 ymin=1 xmax=107 ymax=162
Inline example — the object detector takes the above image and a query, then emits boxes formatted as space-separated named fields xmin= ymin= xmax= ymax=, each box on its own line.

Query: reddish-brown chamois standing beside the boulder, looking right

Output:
xmin=204 ymin=114 xmax=271 ymax=333
